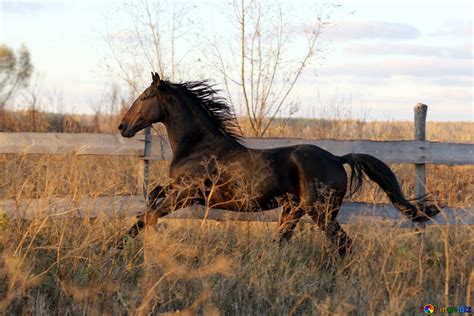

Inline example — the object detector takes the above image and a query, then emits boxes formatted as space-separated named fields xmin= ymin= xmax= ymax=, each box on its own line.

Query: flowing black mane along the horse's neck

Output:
xmin=166 ymin=80 xmax=242 ymax=142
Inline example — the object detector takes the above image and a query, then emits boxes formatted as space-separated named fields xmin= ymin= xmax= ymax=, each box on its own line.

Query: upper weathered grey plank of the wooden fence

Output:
xmin=0 ymin=133 xmax=474 ymax=165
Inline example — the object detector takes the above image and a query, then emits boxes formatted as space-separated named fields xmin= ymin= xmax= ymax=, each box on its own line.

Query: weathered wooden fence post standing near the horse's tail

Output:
xmin=415 ymin=103 xmax=428 ymax=198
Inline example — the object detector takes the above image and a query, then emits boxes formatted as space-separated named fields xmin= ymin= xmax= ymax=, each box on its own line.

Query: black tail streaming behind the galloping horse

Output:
xmin=340 ymin=154 xmax=439 ymax=222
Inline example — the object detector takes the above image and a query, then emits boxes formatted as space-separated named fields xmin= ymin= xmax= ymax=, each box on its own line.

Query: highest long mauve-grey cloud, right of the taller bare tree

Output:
xmin=324 ymin=21 xmax=420 ymax=41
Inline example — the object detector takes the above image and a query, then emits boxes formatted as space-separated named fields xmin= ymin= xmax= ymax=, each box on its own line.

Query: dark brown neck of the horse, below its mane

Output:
xmin=164 ymin=97 xmax=241 ymax=157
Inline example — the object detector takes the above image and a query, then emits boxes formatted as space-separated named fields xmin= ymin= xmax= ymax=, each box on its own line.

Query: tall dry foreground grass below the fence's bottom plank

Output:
xmin=0 ymin=218 xmax=474 ymax=315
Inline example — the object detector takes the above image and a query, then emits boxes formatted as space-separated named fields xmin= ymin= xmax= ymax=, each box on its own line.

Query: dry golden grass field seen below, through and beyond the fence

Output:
xmin=0 ymin=121 xmax=474 ymax=315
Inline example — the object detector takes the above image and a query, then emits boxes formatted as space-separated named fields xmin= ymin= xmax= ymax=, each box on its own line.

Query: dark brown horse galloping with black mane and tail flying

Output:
xmin=118 ymin=73 xmax=438 ymax=255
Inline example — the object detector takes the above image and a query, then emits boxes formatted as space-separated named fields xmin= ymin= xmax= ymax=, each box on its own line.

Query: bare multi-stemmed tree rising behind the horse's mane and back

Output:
xmin=208 ymin=0 xmax=329 ymax=137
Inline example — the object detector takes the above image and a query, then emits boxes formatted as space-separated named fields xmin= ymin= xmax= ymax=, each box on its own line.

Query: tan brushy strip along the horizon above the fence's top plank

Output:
xmin=0 ymin=109 xmax=474 ymax=143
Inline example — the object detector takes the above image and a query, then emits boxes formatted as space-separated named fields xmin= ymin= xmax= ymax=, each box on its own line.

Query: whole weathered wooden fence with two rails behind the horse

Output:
xmin=0 ymin=104 xmax=474 ymax=224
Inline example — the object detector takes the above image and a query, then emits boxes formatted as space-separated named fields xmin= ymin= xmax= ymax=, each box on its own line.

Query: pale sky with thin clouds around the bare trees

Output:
xmin=0 ymin=0 xmax=474 ymax=121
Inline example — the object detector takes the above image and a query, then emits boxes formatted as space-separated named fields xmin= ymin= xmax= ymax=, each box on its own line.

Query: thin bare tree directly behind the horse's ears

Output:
xmin=106 ymin=0 xmax=197 ymax=94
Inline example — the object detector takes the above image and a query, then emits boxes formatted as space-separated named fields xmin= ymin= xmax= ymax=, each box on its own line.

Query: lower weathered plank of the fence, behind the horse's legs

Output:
xmin=0 ymin=195 xmax=474 ymax=227
